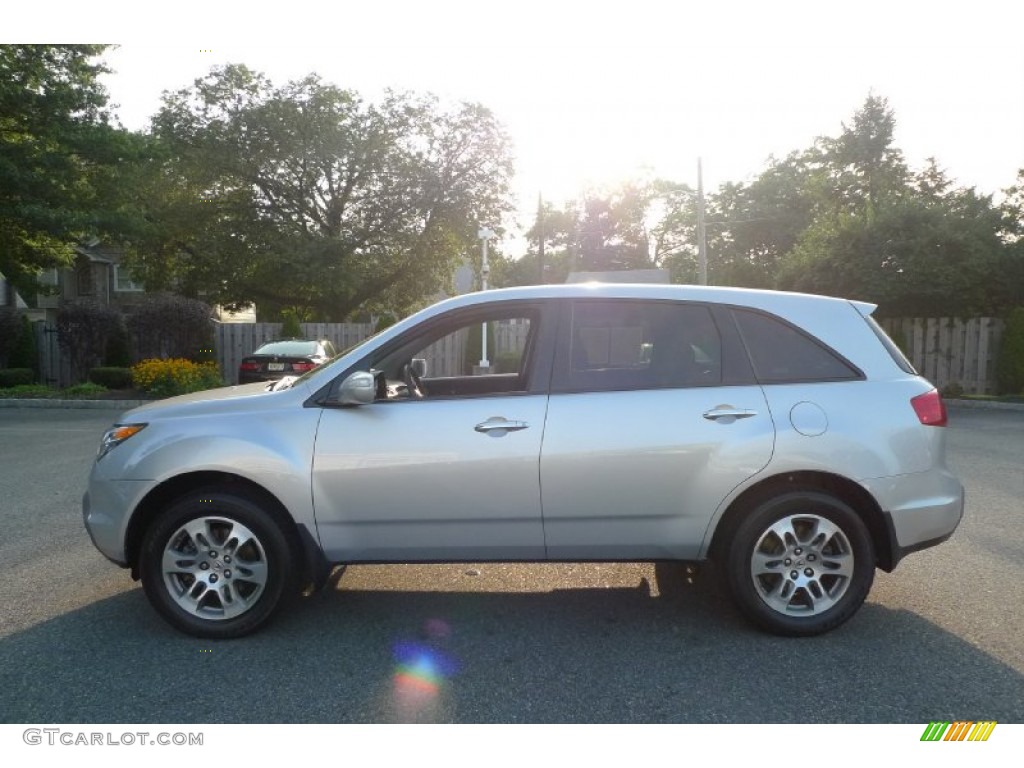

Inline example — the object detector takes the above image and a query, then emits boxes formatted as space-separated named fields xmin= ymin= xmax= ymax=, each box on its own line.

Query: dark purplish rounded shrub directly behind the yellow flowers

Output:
xmin=128 ymin=294 xmax=213 ymax=361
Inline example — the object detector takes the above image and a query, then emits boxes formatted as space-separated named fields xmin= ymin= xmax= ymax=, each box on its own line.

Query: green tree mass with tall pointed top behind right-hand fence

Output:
xmin=776 ymin=96 xmax=1017 ymax=316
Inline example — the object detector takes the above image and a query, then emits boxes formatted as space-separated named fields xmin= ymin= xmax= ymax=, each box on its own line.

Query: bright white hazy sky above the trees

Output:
xmin=8 ymin=0 xmax=1024 ymax=244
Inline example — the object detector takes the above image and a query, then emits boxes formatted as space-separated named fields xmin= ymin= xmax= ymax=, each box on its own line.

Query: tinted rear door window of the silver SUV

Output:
xmin=559 ymin=301 xmax=722 ymax=390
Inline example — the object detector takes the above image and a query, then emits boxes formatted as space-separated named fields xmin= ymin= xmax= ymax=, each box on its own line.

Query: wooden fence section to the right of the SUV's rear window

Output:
xmin=881 ymin=317 xmax=1002 ymax=394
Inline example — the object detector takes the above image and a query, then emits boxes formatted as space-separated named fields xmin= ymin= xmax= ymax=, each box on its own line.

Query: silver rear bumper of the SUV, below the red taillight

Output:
xmin=862 ymin=469 xmax=965 ymax=569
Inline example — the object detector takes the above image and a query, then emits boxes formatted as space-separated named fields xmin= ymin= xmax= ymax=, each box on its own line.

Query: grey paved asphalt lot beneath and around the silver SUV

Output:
xmin=0 ymin=409 xmax=1024 ymax=724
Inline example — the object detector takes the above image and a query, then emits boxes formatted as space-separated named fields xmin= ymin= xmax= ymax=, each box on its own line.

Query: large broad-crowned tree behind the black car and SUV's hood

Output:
xmin=133 ymin=66 xmax=511 ymax=319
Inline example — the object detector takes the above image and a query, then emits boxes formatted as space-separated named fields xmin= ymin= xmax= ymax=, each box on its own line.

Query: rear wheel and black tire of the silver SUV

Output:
xmin=725 ymin=490 xmax=874 ymax=637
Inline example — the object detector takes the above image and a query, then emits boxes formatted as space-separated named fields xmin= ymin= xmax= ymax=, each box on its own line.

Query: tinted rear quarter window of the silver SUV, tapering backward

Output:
xmin=733 ymin=309 xmax=862 ymax=384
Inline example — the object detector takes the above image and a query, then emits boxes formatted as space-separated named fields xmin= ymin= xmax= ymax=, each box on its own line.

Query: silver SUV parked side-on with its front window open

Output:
xmin=83 ymin=285 xmax=964 ymax=638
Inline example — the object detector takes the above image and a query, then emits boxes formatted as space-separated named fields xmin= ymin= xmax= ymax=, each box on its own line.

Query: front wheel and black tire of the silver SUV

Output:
xmin=140 ymin=488 xmax=298 ymax=639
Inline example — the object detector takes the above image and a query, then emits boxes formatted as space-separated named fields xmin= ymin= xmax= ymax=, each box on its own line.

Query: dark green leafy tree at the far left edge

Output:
xmin=0 ymin=45 xmax=146 ymax=296
